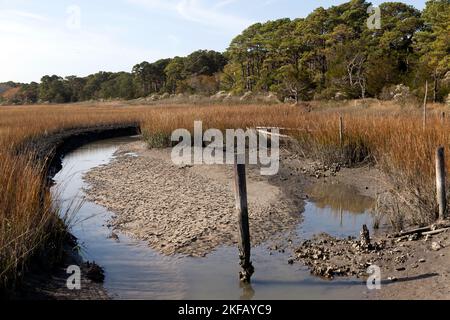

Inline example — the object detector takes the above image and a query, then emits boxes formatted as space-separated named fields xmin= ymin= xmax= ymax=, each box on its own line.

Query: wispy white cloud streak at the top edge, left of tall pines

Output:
xmin=128 ymin=0 xmax=253 ymax=33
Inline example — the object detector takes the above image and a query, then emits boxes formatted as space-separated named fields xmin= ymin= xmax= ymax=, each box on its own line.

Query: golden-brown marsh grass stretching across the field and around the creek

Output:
xmin=0 ymin=101 xmax=450 ymax=287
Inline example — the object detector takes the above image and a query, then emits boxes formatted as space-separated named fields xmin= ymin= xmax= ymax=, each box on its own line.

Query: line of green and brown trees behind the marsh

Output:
xmin=0 ymin=0 xmax=450 ymax=103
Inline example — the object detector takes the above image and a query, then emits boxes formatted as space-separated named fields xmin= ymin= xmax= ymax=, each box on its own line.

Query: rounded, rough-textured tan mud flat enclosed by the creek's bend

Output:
xmin=84 ymin=142 xmax=303 ymax=257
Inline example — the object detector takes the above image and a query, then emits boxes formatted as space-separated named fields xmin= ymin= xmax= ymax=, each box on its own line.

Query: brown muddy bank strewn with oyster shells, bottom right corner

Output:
xmin=292 ymin=222 xmax=450 ymax=299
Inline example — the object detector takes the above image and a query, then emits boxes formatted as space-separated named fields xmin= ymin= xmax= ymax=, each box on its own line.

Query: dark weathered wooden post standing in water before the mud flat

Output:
xmin=234 ymin=155 xmax=255 ymax=283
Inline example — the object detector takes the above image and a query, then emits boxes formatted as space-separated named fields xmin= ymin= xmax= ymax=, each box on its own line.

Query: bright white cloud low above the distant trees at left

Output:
xmin=0 ymin=12 xmax=166 ymax=82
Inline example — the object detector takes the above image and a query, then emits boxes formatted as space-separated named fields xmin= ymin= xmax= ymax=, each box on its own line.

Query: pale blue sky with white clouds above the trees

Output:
xmin=0 ymin=0 xmax=426 ymax=82
